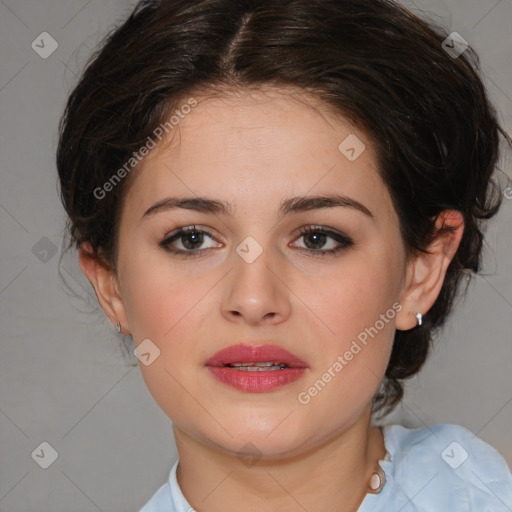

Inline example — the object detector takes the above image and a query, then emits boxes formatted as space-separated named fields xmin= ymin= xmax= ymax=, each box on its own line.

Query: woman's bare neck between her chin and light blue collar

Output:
xmin=174 ymin=407 xmax=386 ymax=512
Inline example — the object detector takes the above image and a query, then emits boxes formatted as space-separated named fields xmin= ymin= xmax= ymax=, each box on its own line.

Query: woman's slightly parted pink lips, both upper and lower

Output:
xmin=205 ymin=344 xmax=309 ymax=393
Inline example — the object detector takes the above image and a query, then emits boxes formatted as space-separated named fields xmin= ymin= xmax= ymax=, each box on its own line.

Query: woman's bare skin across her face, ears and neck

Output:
xmin=79 ymin=88 xmax=463 ymax=512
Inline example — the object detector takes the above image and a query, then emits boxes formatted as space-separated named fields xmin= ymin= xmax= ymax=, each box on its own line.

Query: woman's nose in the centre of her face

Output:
xmin=222 ymin=245 xmax=291 ymax=326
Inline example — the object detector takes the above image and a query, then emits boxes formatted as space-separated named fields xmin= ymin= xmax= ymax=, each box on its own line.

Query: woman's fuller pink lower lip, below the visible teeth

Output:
xmin=207 ymin=366 xmax=306 ymax=393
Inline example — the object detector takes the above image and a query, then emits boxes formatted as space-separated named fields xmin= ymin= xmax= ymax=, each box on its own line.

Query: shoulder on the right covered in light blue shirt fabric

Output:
xmin=384 ymin=424 xmax=512 ymax=512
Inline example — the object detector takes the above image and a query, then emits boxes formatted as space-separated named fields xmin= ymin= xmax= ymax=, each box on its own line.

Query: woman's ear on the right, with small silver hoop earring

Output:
xmin=395 ymin=210 xmax=464 ymax=331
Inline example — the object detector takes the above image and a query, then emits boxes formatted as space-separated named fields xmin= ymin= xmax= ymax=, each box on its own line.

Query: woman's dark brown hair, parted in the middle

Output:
xmin=57 ymin=0 xmax=511 ymax=414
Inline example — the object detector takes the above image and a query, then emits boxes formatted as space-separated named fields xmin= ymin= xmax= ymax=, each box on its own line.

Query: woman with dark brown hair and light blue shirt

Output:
xmin=57 ymin=0 xmax=512 ymax=512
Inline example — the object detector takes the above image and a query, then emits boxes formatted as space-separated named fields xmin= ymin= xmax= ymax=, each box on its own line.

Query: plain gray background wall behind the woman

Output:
xmin=0 ymin=0 xmax=512 ymax=512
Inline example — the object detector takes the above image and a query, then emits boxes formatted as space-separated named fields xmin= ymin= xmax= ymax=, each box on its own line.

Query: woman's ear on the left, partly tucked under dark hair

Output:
xmin=78 ymin=242 xmax=130 ymax=334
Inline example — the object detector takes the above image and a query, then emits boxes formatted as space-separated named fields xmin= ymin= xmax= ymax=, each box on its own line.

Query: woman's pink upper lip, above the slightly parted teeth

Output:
xmin=205 ymin=343 xmax=308 ymax=368
